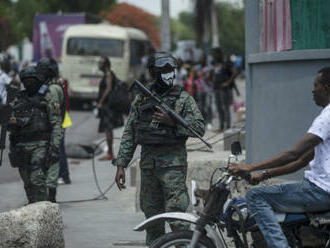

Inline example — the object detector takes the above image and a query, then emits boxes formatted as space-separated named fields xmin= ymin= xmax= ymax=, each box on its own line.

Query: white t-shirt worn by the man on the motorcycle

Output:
xmin=305 ymin=104 xmax=330 ymax=193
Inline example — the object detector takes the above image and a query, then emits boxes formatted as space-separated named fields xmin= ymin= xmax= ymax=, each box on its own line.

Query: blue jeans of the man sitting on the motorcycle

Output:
xmin=246 ymin=179 xmax=330 ymax=248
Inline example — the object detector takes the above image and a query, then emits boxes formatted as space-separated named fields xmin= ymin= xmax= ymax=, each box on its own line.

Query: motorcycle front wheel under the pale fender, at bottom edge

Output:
xmin=150 ymin=231 xmax=216 ymax=248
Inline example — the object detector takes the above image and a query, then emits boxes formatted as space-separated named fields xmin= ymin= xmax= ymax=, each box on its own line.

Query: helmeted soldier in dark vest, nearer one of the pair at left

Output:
xmin=8 ymin=66 xmax=62 ymax=203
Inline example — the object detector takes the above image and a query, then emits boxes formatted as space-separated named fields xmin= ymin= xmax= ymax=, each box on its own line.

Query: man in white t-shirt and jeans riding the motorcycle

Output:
xmin=229 ymin=67 xmax=330 ymax=248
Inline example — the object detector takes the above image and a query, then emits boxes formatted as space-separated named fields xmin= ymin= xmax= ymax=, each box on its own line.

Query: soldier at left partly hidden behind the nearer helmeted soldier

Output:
xmin=37 ymin=58 xmax=66 ymax=202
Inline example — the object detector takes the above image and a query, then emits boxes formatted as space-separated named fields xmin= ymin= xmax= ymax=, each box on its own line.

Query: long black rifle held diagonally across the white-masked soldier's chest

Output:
xmin=130 ymin=80 xmax=212 ymax=148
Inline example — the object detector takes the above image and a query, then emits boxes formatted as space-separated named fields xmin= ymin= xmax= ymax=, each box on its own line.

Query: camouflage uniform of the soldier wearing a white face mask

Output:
xmin=115 ymin=85 xmax=205 ymax=245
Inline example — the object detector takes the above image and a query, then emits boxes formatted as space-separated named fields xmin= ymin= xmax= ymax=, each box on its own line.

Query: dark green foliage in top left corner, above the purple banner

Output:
xmin=0 ymin=0 xmax=116 ymax=49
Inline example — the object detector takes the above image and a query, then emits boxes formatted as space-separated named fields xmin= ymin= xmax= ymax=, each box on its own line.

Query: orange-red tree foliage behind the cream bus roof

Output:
xmin=103 ymin=3 xmax=160 ymax=49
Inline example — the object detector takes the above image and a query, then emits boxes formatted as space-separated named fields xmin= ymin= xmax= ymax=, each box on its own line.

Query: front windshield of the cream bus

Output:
xmin=67 ymin=37 xmax=124 ymax=57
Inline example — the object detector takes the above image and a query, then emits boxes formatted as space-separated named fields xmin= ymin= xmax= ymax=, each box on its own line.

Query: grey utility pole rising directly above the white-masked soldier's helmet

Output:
xmin=161 ymin=0 xmax=171 ymax=52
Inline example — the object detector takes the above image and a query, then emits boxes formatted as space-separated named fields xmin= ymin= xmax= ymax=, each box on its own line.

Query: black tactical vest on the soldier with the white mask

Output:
xmin=134 ymin=86 xmax=187 ymax=146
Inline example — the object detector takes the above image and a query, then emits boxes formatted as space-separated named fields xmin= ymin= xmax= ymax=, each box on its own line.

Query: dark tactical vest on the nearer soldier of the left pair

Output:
xmin=9 ymin=92 xmax=51 ymax=143
